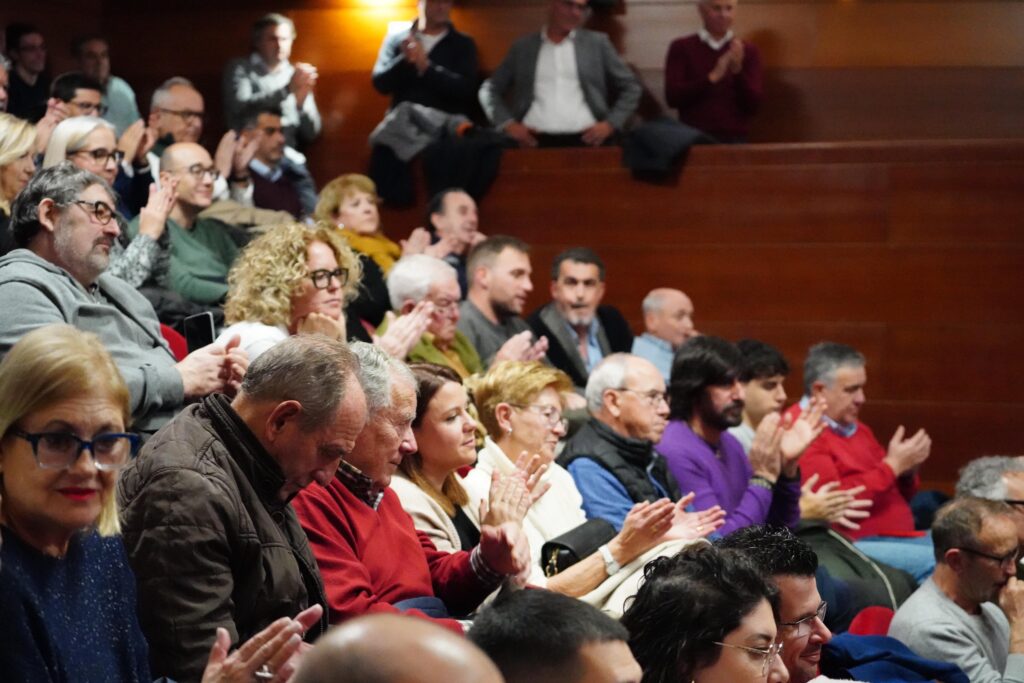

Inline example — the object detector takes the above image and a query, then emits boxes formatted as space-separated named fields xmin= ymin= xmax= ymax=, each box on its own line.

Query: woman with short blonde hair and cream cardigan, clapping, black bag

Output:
xmin=465 ymin=360 xmax=714 ymax=596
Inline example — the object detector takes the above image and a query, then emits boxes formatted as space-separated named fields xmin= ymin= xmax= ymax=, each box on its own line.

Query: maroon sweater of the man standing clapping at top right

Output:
xmin=665 ymin=34 xmax=762 ymax=141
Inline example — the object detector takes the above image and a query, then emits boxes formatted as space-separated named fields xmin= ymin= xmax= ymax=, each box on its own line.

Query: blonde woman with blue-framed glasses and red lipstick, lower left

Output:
xmin=0 ymin=325 xmax=319 ymax=683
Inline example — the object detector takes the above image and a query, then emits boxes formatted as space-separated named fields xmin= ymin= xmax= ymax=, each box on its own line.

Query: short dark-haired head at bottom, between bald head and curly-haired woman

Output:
xmin=469 ymin=591 xmax=643 ymax=683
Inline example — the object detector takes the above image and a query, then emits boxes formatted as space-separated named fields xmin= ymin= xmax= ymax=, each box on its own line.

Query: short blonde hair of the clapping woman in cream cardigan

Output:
xmin=465 ymin=360 xmax=572 ymax=438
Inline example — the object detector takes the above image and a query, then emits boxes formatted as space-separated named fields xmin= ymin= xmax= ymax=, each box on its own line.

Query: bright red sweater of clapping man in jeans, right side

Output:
xmin=787 ymin=405 xmax=918 ymax=539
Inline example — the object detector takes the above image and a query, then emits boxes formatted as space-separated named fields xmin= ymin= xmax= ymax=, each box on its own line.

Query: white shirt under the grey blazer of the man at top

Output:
xmin=522 ymin=31 xmax=597 ymax=133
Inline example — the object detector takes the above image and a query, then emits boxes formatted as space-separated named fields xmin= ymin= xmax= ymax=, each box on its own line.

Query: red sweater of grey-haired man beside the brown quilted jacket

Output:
xmin=292 ymin=477 xmax=495 ymax=634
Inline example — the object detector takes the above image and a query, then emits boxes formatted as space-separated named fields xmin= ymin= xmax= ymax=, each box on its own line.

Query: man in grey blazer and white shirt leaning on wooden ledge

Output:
xmin=480 ymin=0 xmax=641 ymax=147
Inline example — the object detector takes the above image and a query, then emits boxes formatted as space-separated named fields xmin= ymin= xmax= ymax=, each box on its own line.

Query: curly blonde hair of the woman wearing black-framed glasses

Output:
xmin=224 ymin=223 xmax=362 ymax=327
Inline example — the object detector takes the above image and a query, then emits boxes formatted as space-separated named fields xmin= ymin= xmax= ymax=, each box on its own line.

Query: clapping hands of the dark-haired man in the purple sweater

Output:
xmin=749 ymin=398 xmax=828 ymax=482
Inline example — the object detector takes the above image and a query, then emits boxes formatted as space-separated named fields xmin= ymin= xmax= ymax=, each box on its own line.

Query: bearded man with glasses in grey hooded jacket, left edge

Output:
xmin=0 ymin=162 xmax=248 ymax=432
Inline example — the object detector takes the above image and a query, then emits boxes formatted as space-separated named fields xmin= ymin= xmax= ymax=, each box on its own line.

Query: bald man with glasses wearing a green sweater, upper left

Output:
xmin=128 ymin=142 xmax=239 ymax=312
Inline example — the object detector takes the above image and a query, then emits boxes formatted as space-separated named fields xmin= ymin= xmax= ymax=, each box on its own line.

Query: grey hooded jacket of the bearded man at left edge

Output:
xmin=0 ymin=249 xmax=184 ymax=432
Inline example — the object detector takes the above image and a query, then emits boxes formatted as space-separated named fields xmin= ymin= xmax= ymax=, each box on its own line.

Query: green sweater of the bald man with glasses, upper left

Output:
xmin=128 ymin=216 xmax=239 ymax=304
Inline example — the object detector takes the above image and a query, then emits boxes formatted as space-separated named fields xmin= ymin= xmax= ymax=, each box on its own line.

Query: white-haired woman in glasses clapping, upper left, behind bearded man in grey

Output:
xmin=43 ymin=116 xmax=176 ymax=288
